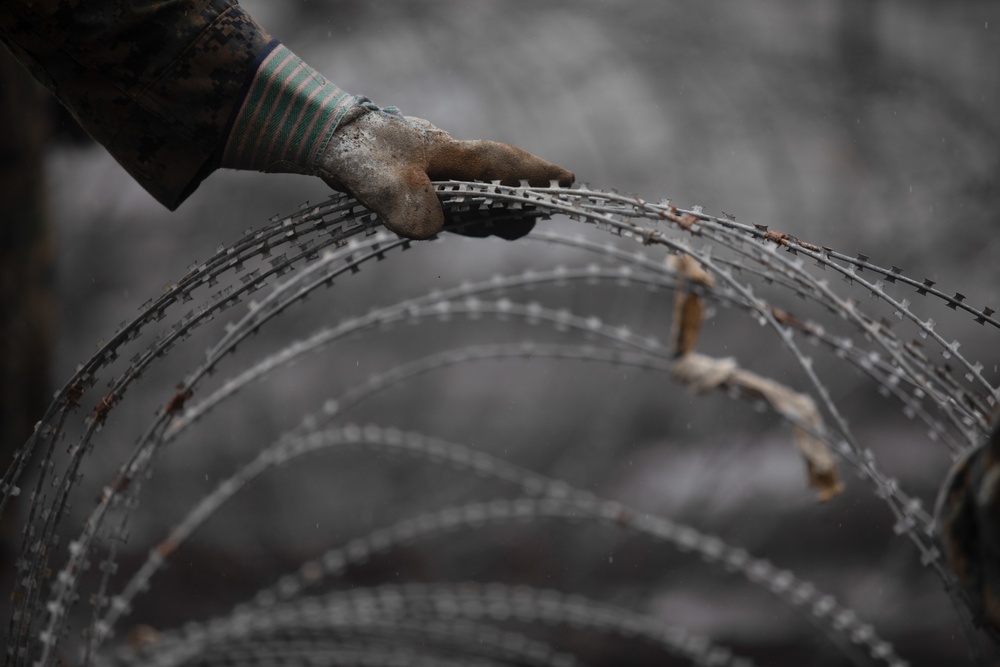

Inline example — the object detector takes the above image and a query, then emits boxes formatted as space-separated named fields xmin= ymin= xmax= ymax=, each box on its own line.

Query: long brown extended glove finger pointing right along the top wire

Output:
xmin=427 ymin=139 xmax=575 ymax=187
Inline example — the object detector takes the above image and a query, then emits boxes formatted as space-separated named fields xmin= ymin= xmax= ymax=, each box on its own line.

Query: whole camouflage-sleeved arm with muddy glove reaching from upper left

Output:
xmin=0 ymin=0 xmax=573 ymax=238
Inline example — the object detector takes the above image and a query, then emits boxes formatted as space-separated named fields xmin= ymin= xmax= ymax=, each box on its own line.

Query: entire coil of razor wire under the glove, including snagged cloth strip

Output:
xmin=0 ymin=182 xmax=1000 ymax=667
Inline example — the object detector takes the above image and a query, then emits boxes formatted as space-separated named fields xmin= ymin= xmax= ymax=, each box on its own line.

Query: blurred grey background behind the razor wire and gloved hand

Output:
xmin=5 ymin=0 xmax=1000 ymax=665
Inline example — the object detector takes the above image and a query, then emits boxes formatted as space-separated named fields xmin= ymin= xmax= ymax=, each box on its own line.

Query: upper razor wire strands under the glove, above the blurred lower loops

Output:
xmin=0 ymin=182 xmax=1000 ymax=667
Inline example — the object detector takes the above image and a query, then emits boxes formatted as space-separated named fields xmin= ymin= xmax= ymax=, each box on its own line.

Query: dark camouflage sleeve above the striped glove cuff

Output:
xmin=0 ymin=0 xmax=275 ymax=209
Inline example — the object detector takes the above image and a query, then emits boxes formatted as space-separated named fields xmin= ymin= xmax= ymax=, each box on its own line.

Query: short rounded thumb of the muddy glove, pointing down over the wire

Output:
xmin=323 ymin=165 xmax=444 ymax=240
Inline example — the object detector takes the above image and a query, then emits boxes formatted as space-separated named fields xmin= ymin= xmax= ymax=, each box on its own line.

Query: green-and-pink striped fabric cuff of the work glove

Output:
xmin=222 ymin=43 xmax=358 ymax=174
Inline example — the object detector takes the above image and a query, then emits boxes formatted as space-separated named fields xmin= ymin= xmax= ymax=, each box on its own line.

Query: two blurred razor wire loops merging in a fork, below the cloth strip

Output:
xmin=94 ymin=425 xmax=908 ymax=667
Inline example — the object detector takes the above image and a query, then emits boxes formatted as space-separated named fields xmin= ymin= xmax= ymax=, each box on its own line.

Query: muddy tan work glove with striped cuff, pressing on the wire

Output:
xmin=222 ymin=44 xmax=573 ymax=239
